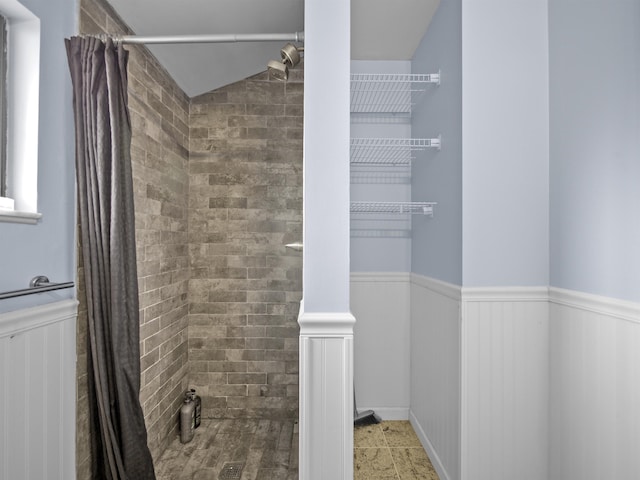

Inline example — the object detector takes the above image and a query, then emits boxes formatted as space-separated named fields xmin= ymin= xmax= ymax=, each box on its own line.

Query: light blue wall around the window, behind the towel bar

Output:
xmin=0 ymin=0 xmax=78 ymax=312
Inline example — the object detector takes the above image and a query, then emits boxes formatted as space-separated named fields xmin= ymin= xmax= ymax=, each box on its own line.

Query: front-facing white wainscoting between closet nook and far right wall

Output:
xmin=461 ymin=287 xmax=552 ymax=480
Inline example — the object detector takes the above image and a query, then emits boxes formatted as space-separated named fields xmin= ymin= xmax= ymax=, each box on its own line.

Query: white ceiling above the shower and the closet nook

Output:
xmin=108 ymin=0 xmax=440 ymax=97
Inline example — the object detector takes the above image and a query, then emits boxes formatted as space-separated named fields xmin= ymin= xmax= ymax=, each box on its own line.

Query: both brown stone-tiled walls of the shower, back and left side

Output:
xmin=76 ymin=0 xmax=303 ymax=479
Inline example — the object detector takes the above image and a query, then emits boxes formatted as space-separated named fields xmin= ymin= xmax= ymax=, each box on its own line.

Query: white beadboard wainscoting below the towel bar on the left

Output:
xmin=0 ymin=300 xmax=77 ymax=480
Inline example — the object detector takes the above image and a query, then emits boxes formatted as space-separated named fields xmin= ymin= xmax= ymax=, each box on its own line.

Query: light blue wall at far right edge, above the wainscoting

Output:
xmin=549 ymin=0 xmax=640 ymax=301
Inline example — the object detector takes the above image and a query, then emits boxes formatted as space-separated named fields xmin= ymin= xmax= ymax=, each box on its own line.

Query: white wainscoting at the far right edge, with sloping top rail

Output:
xmin=549 ymin=288 xmax=640 ymax=480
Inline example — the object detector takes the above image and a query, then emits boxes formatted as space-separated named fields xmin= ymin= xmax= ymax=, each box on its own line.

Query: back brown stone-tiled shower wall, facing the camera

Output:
xmin=189 ymin=67 xmax=303 ymax=418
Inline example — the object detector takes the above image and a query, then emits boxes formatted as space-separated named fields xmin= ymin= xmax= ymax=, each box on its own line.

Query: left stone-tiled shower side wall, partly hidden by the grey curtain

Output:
xmin=76 ymin=0 xmax=189 ymax=472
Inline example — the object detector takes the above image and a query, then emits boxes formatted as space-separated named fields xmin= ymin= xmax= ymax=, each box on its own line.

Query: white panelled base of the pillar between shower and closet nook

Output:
xmin=298 ymin=307 xmax=355 ymax=480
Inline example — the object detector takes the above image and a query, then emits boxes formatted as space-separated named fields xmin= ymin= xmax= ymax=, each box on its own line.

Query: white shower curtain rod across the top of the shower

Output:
xmin=112 ymin=32 xmax=304 ymax=44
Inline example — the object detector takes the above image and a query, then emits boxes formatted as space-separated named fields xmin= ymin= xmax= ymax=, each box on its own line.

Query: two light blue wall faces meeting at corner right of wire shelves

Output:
xmin=412 ymin=0 xmax=549 ymax=287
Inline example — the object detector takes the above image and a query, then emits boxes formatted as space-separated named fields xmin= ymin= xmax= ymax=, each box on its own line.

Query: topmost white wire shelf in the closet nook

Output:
xmin=351 ymin=72 xmax=440 ymax=115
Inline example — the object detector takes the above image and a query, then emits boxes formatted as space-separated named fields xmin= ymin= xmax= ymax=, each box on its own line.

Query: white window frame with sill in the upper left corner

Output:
xmin=0 ymin=0 xmax=42 ymax=224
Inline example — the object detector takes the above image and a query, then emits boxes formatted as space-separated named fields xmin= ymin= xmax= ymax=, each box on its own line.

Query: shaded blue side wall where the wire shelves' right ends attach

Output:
xmin=411 ymin=0 xmax=462 ymax=285
